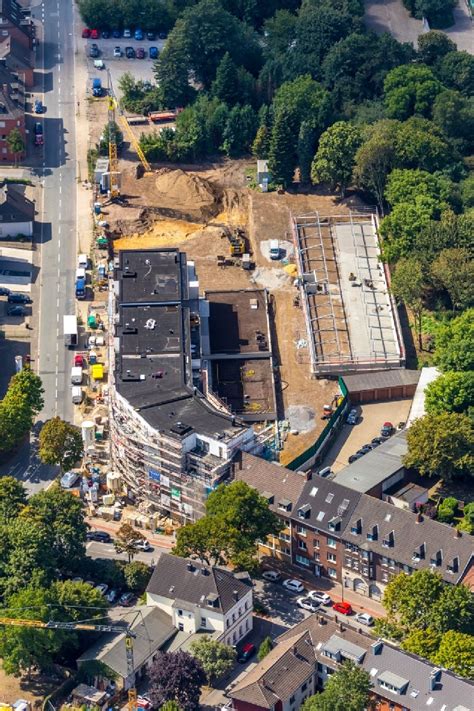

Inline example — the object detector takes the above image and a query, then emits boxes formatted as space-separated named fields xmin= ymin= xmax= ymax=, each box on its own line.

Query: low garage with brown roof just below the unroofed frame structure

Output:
xmin=343 ymin=368 xmax=420 ymax=405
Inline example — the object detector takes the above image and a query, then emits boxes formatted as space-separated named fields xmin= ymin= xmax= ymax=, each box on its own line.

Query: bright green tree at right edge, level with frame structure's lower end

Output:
xmin=435 ymin=309 xmax=474 ymax=372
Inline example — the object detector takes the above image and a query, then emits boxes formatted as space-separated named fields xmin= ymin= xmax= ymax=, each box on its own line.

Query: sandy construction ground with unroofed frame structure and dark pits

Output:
xmin=87 ymin=89 xmax=403 ymax=465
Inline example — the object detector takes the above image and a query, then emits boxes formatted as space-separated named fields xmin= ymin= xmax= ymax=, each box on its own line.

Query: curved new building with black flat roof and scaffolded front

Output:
xmin=110 ymin=249 xmax=254 ymax=523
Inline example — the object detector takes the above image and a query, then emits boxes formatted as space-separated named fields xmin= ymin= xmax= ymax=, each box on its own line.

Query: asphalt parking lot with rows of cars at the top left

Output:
xmin=79 ymin=37 xmax=166 ymax=97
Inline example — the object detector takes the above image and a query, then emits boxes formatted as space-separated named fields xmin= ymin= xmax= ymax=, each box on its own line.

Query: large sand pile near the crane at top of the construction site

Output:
xmin=153 ymin=168 xmax=220 ymax=220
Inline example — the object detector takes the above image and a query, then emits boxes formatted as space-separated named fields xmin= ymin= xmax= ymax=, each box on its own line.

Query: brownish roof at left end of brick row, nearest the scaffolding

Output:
xmin=234 ymin=452 xmax=306 ymax=514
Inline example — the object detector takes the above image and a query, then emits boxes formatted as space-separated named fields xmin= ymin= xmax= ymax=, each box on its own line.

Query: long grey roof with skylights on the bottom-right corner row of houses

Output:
xmin=276 ymin=614 xmax=474 ymax=711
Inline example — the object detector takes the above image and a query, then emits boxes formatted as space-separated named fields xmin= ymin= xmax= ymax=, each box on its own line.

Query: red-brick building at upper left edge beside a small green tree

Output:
xmin=0 ymin=62 xmax=26 ymax=163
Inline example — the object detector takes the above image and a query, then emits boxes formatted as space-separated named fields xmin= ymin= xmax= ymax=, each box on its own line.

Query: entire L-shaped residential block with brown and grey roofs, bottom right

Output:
xmin=229 ymin=613 xmax=474 ymax=711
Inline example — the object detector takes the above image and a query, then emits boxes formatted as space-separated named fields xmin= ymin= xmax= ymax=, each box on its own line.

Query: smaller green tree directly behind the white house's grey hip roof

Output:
xmin=172 ymin=516 xmax=229 ymax=565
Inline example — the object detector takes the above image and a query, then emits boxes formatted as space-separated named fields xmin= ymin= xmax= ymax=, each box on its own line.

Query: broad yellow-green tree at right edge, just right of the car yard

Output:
xmin=403 ymin=412 xmax=474 ymax=480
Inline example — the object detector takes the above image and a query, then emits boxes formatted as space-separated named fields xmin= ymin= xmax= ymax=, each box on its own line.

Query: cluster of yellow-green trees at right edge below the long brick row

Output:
xmin=376 ymin=569 xmax=474 ymax=679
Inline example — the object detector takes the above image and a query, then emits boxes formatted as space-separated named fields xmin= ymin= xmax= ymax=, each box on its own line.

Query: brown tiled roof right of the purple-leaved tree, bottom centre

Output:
xmin=229 ymin=631 xmax=315 ymax=709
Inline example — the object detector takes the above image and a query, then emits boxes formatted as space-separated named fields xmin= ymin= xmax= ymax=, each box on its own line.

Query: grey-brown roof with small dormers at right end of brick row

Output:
xmin=343 ymin=494 xmax=474 ymax=583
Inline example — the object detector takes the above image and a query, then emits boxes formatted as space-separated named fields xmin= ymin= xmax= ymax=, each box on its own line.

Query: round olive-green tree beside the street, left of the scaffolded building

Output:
xmin=39 ymin=417 xmax=84 ymax=472
